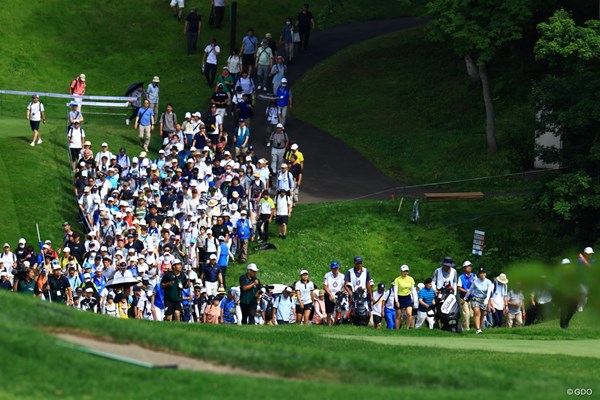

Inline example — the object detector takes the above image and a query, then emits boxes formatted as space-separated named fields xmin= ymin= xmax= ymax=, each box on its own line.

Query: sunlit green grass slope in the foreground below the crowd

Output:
xmin=0 ymin=295 xmax=600 ymax=399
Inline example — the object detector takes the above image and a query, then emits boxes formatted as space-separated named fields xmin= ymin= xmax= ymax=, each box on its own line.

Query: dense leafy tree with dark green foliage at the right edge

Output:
xmin=533 ymin=10 xmax=600 ymax=239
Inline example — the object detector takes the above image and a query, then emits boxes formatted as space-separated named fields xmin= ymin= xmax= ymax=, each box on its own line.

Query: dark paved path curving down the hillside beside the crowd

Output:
xmin=220 ymin=17 xmax=422 ymax=203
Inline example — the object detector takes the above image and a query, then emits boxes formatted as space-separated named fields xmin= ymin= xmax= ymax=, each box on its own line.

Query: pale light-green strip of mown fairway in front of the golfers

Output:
xmin=327 ymin=332 xmax=600 ymax=358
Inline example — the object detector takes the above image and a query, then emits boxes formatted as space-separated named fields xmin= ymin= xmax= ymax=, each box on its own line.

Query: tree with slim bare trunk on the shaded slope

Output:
xmin=426 ymin=0 xmax=531 ymax=153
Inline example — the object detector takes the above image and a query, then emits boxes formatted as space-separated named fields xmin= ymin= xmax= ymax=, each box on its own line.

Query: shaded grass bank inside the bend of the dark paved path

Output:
xmin=294 ymin=28 xmax=533 ymax=191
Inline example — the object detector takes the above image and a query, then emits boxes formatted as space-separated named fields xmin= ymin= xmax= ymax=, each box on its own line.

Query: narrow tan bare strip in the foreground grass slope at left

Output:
xmin=55 ymin=333 xmax=284 ymax=379
